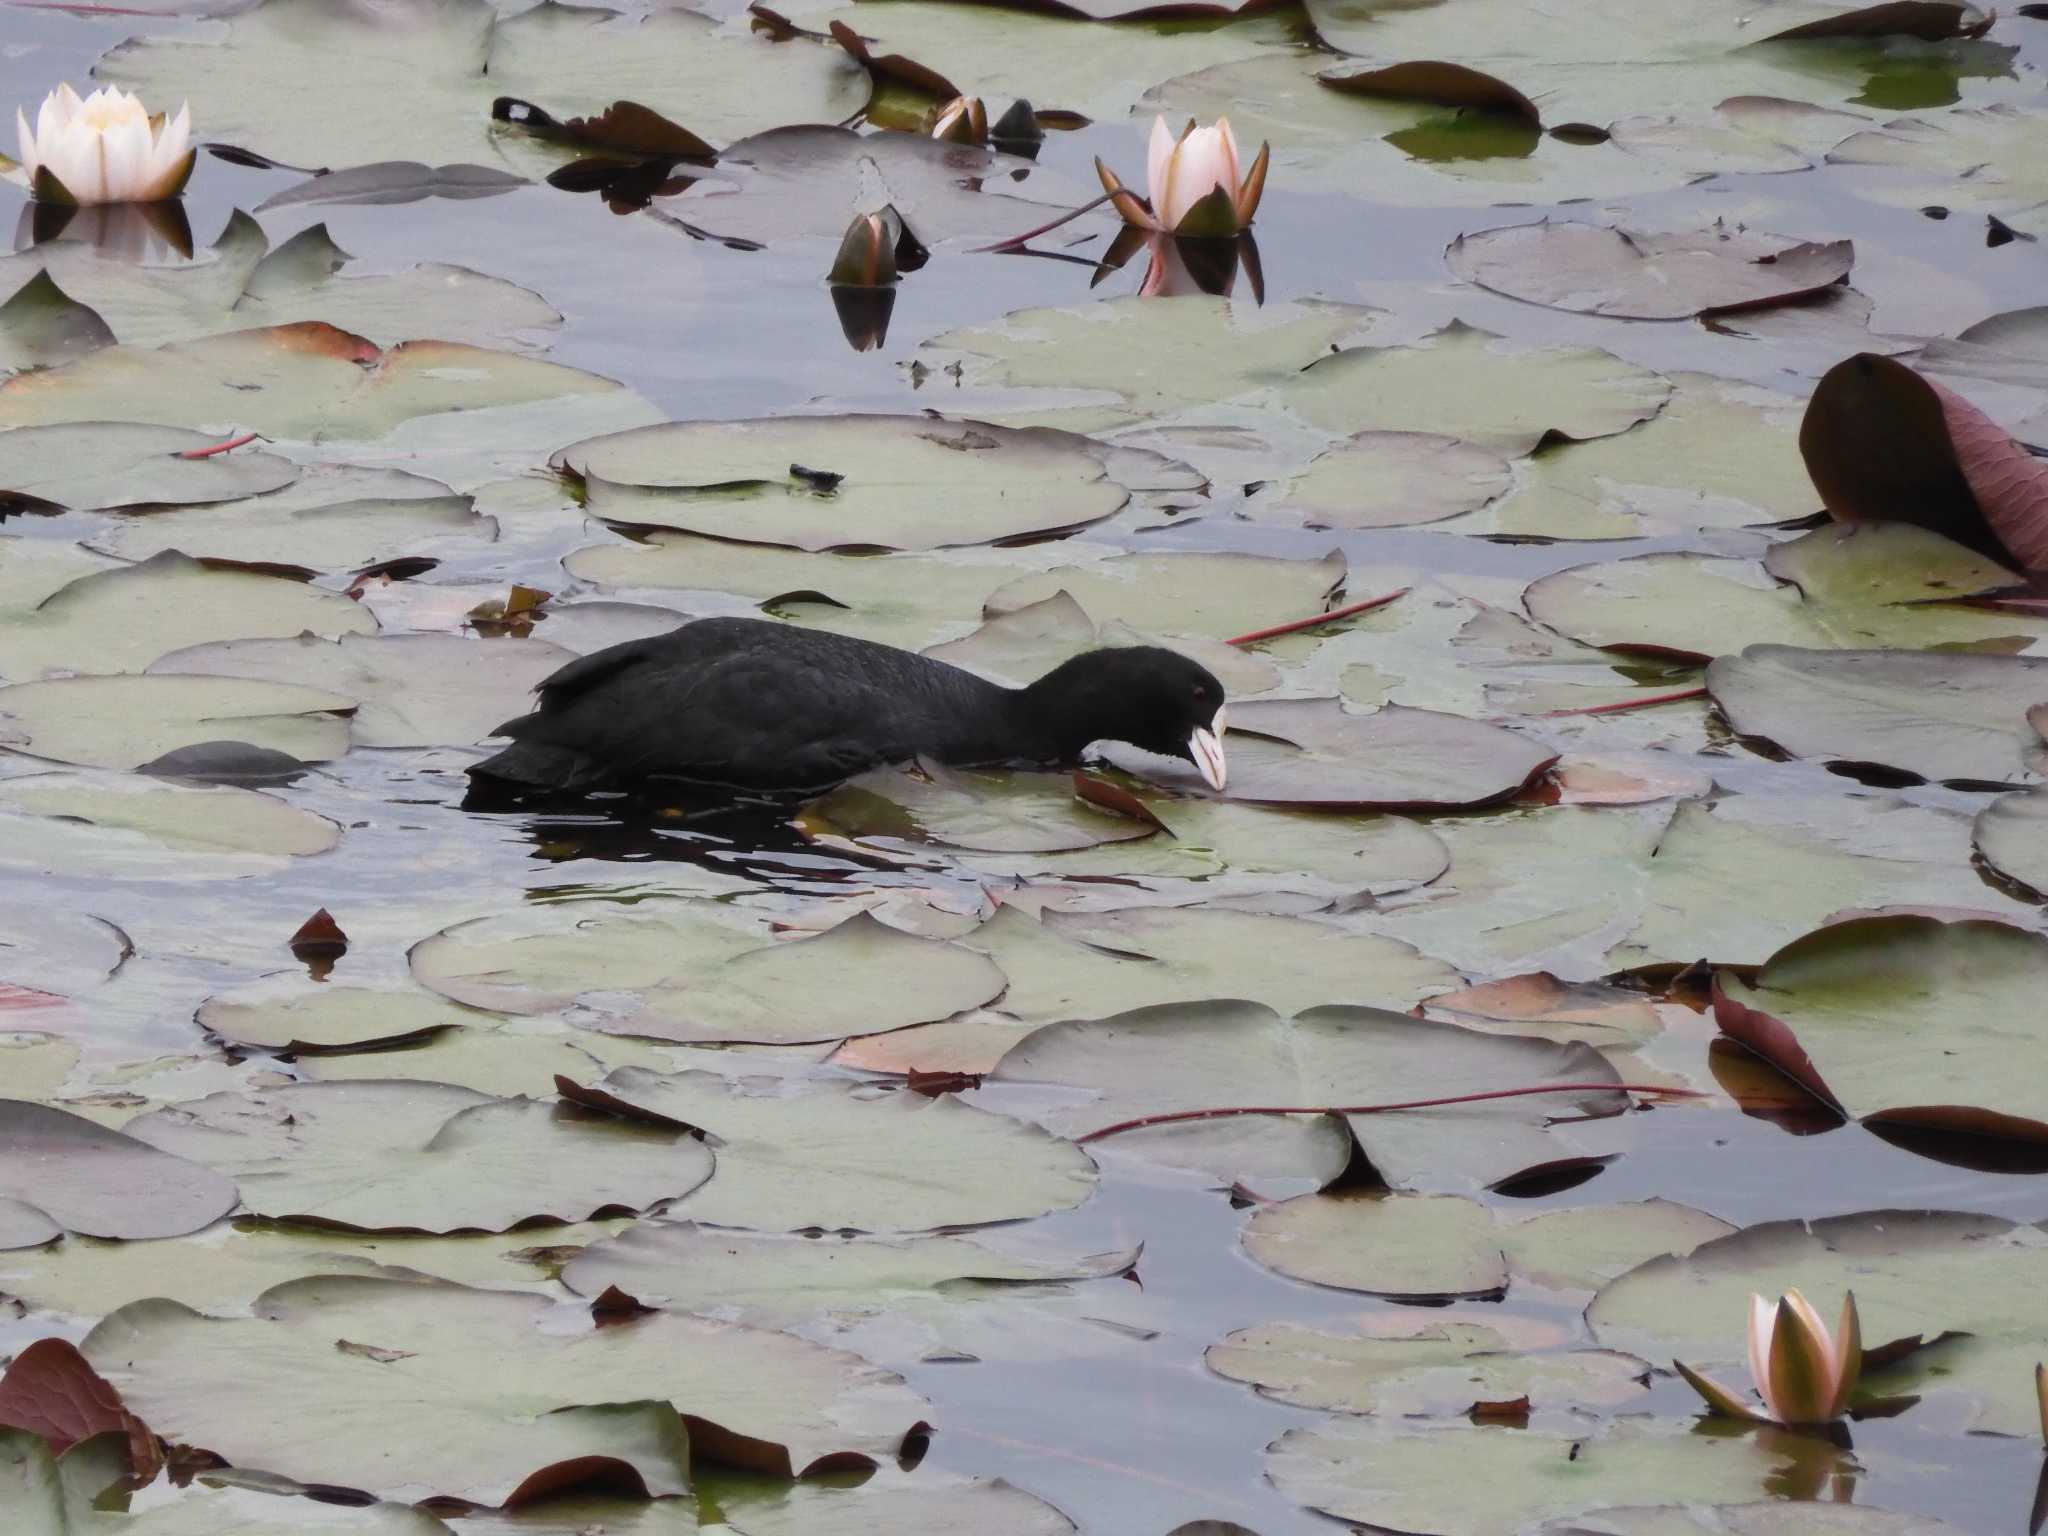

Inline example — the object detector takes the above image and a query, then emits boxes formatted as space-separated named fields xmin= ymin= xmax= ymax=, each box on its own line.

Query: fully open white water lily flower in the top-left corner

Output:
xmin=10 ymin=84 xmax=199 ymax=203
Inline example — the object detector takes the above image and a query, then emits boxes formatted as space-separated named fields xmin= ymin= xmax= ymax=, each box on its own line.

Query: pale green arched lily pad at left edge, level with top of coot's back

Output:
xmin=0 ymin=551 xmax=377 ymax=682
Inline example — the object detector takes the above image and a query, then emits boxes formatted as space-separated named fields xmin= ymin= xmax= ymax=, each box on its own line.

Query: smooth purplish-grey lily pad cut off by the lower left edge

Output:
xmin=0 ymin=1098 xmax=236 ymax=1243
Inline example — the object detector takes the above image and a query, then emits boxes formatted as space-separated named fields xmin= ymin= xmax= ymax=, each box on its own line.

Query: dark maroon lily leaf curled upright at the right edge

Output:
xmin=1800 ymin=352 xmax=2048 ymax=569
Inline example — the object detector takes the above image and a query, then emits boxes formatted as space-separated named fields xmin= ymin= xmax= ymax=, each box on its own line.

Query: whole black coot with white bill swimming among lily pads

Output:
xmin=469 ymin=618 xmax=1223 ymax=795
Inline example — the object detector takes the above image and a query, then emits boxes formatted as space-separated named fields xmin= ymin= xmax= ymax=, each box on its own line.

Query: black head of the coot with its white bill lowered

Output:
xmin=1028 ymin=645 xmax=1225 ymax=788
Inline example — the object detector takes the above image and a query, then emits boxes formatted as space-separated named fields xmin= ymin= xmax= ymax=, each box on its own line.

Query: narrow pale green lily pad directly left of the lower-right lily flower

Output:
xmin=1204 ymin=1323 xmax=1651 ymax=1417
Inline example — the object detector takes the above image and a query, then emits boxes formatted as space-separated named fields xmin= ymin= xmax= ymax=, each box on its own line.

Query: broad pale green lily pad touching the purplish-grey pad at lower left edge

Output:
xmin=129 ymin=1081 xmax=711 ymax=1233
